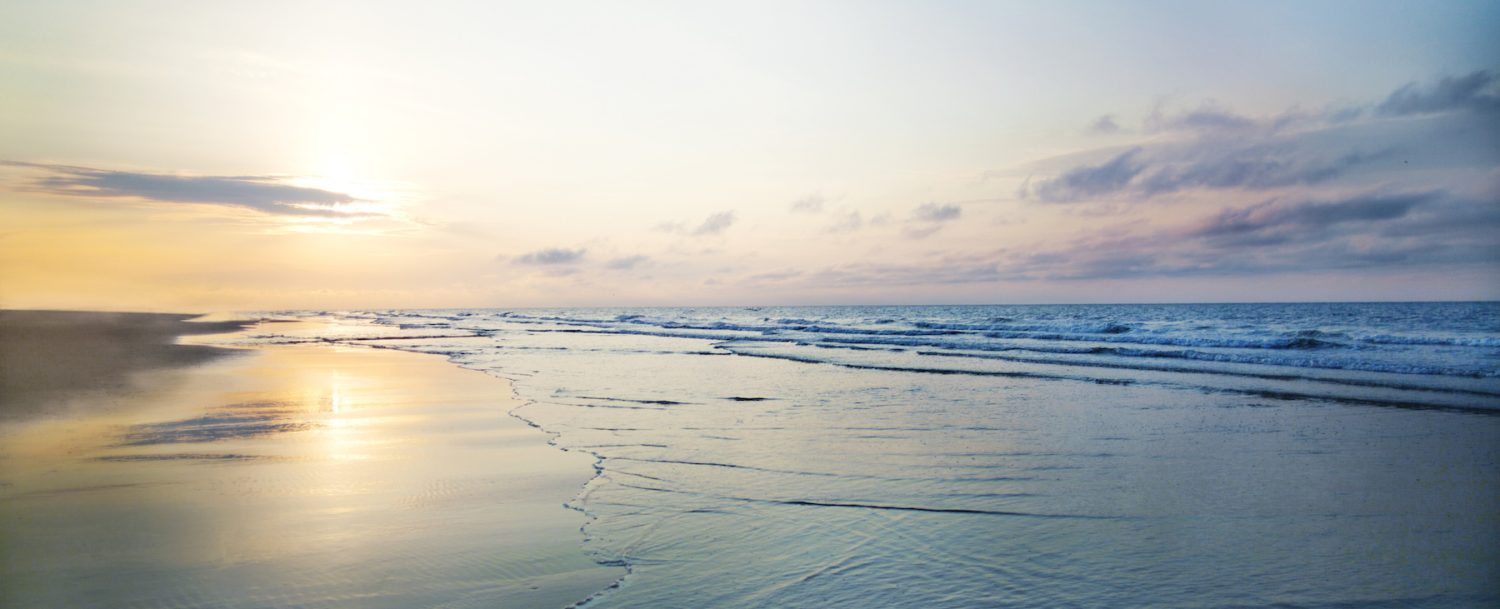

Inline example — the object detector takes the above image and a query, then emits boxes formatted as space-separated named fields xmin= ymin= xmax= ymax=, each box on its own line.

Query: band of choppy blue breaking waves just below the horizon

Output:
xmin=351 ymin=308 xmax=1500 ymax=378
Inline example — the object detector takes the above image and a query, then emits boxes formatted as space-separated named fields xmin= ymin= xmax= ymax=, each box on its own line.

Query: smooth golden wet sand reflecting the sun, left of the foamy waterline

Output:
xmin=0 ymin=313 xmax=623 ymax=609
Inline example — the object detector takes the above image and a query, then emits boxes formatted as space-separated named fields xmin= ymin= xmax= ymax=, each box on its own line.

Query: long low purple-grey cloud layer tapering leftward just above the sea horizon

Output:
xmin=807 ymin=189 xmax=1500 ymax=287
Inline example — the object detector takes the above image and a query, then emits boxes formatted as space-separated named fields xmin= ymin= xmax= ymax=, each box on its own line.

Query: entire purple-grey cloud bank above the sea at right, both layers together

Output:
xmin=756 ymin=71 xmax=1500 ymax=289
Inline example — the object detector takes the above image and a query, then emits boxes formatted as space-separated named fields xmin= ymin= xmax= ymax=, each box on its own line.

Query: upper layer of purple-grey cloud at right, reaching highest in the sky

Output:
xmin=1019 ymin=71 xmax=1500 ymax=204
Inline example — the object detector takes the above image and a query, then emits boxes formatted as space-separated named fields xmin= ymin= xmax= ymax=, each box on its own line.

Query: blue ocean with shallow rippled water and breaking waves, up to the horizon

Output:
xmin=246 ymin=303 xmax=1500 ymax=608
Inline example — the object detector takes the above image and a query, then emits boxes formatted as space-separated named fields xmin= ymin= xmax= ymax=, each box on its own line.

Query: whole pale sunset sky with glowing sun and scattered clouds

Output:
xmin=0 ymin=2 xmax=1500 ymax=311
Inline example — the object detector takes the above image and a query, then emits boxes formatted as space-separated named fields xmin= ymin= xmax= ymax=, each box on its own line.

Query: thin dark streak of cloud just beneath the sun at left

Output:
xmin=0 ymin=161 xmax=375 ymax=218
